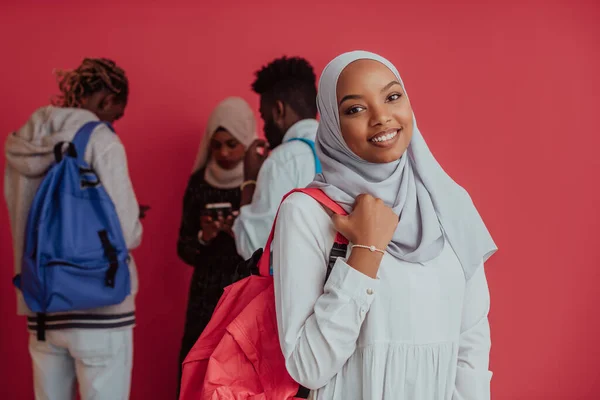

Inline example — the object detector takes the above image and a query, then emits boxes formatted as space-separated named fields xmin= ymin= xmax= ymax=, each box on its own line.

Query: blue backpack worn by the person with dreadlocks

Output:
xmin=14 ymin=121 xmax=131 ymax=340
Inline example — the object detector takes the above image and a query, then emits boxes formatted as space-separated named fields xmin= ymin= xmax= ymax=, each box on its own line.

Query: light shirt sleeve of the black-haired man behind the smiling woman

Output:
xmin=233 ymin=159 xmax=296 ymax=260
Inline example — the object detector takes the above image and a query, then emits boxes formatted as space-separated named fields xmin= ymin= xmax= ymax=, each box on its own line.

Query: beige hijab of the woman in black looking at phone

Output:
xmin=192 ymin=97 xmax=257 ymax=189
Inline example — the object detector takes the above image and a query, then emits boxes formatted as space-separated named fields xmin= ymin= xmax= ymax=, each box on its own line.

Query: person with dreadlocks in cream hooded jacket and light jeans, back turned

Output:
xmin=4 ymin=58 xmax=142 ymax=400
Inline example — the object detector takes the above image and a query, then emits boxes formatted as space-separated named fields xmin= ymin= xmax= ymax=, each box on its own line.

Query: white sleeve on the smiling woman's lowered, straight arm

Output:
xmin=452 ymin=264 xmax=492 ymax=400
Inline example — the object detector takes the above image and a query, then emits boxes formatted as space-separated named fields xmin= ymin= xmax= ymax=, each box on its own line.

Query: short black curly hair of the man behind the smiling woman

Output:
xmin=252 ymin=56 xmax=317 ymax=119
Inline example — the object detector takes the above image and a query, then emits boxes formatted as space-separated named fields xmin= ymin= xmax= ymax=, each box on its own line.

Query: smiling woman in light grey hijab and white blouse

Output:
xmin=272 ymin=51 xmax=496 ymax=400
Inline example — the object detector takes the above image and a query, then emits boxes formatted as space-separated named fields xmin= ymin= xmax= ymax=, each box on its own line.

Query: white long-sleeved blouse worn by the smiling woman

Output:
xmin=272 ymin=193 xmax=492 ymax=400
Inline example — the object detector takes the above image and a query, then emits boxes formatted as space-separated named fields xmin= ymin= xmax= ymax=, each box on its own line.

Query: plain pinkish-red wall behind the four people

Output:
xmin=0 ymin=0 xmax=600 ymax=400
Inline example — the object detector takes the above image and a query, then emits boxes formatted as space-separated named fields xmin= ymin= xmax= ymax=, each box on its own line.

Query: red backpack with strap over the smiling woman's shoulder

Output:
xmin=179 ymin=189 xmax=348 ymax=400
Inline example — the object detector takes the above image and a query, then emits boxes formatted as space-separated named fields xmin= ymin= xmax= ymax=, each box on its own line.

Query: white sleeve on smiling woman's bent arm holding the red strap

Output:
xmin=272 ymin=194 xmax=379 ymax=389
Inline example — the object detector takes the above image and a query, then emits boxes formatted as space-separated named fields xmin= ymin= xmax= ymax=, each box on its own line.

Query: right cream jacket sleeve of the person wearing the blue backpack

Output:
xmin=92 ymin=141 xmax=142 ymax=250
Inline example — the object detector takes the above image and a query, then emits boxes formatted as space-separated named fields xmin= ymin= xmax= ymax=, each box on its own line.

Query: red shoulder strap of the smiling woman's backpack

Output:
xmin=258 ymin=188 xmax=348 ymax=277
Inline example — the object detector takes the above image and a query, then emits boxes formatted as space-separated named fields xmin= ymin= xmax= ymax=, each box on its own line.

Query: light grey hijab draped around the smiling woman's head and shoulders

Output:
xmin=310 ymin=51 xmax=497 ymax=279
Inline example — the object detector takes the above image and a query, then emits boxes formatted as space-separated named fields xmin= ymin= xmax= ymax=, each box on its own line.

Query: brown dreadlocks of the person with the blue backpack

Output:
xmin=52 ymin=58 xmax=129 ymax=108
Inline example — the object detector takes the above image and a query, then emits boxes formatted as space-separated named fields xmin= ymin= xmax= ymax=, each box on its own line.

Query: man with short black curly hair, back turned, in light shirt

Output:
xmin=233 ymin=57 xmax=318 ymax=259
